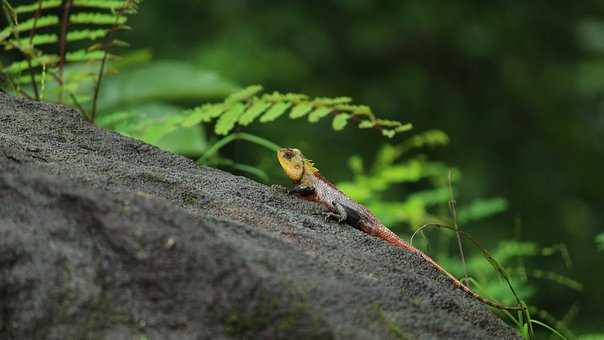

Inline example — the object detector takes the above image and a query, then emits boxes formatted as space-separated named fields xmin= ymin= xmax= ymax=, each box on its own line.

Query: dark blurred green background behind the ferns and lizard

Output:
xmin=4 ymin=0 xmax=604 ymax=334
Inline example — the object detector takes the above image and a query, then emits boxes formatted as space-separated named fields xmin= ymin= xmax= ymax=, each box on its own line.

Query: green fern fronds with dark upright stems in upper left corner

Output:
xmin=0 ymin=0 xmax=139 ymax=120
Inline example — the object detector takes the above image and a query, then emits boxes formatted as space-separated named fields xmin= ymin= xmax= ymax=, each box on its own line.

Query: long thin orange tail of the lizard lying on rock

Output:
xmin=370 ymin=227 xmax=522 ymax=310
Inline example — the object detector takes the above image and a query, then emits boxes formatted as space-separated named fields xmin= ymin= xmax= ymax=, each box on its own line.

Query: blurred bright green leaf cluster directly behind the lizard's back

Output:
xmin=337 ymin=130 xmax=462 ymax=229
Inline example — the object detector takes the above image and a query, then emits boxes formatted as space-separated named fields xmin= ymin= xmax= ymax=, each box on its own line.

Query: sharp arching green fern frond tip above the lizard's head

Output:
xmin=185 ymin=85 xmax=412 ymax=137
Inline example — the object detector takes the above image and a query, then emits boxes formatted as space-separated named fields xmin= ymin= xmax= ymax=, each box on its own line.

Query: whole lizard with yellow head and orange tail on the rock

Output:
xmin=277 ymin=148 xmax=522 ymax=310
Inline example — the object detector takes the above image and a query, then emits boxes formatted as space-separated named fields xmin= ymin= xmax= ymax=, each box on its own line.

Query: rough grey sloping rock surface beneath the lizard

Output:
xmin=0 ymin=93 xmax=518 ymax=339
